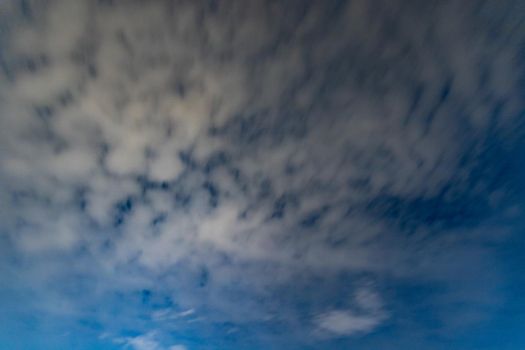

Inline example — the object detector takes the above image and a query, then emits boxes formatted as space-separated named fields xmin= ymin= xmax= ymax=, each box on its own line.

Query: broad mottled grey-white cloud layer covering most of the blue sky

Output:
xmin=0 ymin=1 xmax=524 ymax=349
